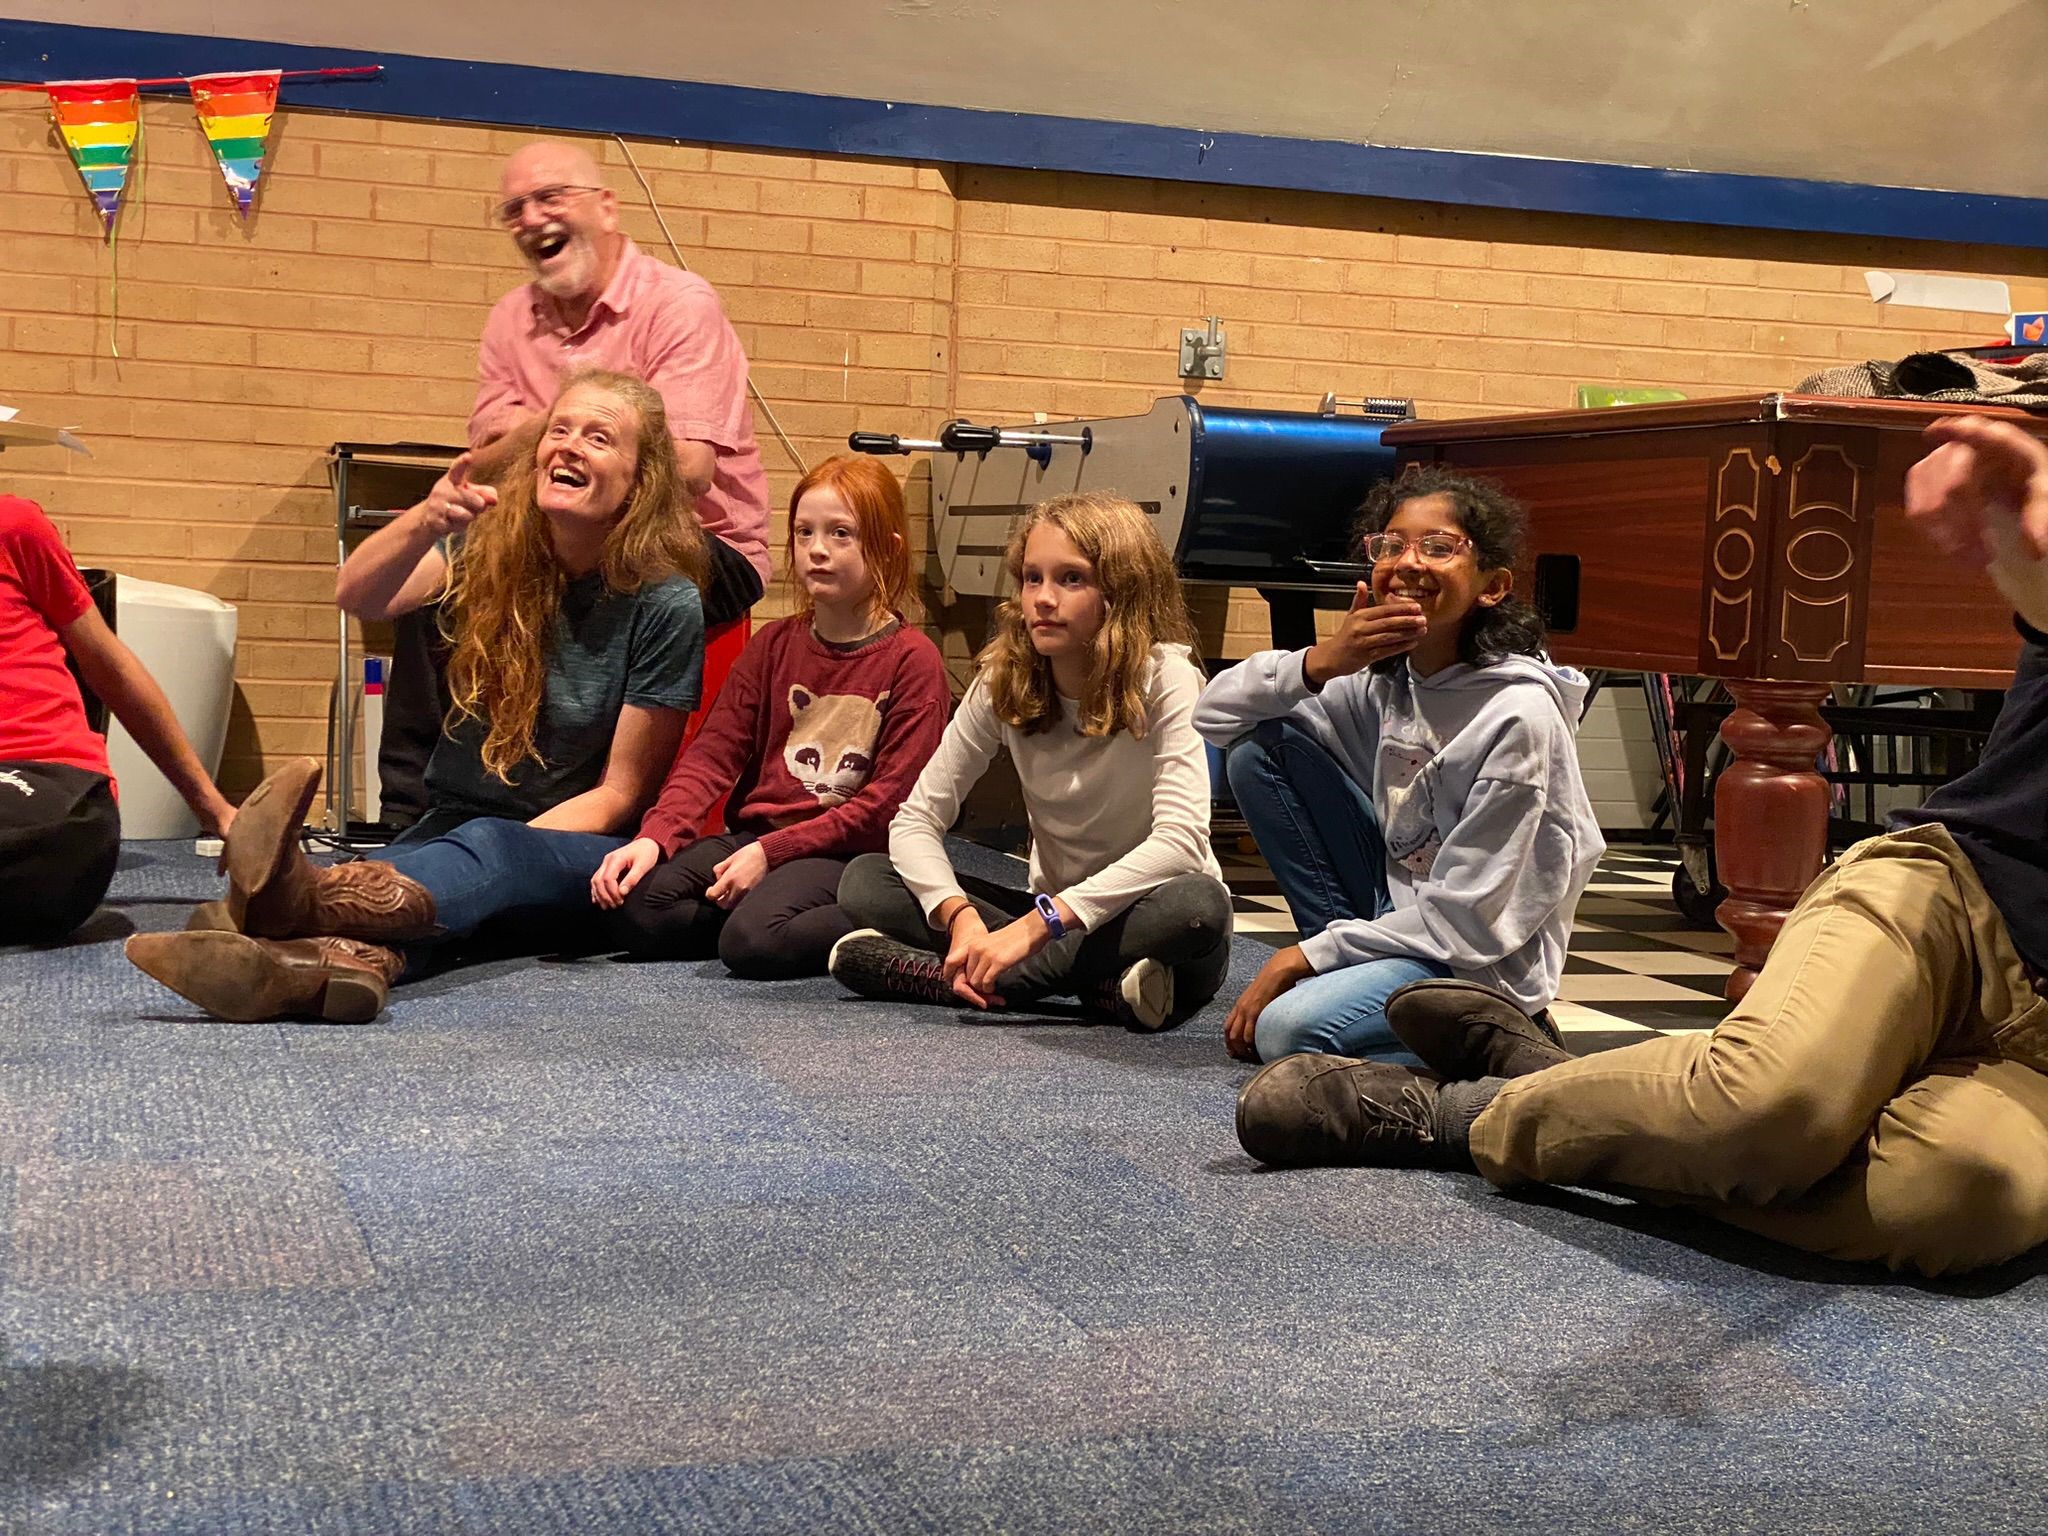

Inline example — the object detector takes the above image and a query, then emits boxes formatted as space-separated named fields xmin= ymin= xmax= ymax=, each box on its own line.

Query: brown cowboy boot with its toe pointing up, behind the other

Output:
xmin=218 ymin=758 xmax=436 ymax=944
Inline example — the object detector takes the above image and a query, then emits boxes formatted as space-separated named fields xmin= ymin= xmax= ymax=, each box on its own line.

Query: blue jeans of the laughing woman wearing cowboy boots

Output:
xmin=383 ymin=815 xmax=627 ymax=938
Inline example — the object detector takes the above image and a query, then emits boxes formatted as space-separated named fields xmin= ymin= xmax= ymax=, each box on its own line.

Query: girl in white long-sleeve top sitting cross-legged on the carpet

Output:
xmin=831 ymin=494 xmax=1231 ymax=1030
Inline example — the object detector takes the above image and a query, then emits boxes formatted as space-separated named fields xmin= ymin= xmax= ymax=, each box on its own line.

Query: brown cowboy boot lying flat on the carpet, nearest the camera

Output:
xmin=125 ymin=930 xmax=406 ymax=1024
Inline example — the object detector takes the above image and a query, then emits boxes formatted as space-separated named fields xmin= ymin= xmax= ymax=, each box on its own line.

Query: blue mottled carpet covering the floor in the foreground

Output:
xmin=0 ymin=844 xmax=2048 ymax=1536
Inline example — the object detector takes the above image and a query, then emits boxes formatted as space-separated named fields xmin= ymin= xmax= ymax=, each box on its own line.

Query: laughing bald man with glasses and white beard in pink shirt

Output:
xmin=469 ymin=141 xmax=768 ymax=625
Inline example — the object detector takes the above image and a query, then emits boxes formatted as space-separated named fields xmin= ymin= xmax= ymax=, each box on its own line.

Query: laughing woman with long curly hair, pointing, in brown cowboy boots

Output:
xmin=127 ymin=373 xmax=707 ymax=1024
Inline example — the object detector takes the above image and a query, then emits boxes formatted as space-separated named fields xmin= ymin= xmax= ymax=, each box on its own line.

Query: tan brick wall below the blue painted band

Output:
xmin=0 ymin=96 xmax=2048 ymax=793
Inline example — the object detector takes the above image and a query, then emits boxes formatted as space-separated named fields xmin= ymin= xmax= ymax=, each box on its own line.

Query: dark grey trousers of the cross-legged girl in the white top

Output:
xmin=840 ymin=854 xmax=1231 ymax=1016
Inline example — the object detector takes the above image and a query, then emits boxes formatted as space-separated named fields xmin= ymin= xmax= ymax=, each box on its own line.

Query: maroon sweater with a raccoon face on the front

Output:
xmin=639 ymin=616 xmax=952 ymax=868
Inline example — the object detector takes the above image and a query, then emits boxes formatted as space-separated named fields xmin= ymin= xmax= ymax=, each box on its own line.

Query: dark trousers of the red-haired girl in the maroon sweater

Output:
xmin=612 ymin=831 xmax=854 ymax=981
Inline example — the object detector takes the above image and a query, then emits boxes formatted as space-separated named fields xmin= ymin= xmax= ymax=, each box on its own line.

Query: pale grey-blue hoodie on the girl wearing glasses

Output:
xmin=1194 ymin=651 xmax=1606 ymax=1012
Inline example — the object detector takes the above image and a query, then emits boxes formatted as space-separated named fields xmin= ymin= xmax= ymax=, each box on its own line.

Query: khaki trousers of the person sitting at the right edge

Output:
xmin=1473 ymin=827 xmax=2048 ymax=1268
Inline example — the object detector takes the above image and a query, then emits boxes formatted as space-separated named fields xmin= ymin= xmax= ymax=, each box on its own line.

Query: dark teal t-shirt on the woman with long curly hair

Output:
xmin=426 ymin=573 xmax=705 ymax=821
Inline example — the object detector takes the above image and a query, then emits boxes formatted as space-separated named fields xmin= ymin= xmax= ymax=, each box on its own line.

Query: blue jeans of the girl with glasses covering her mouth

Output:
xmin=1225 ymin=719 xmax=1450 ymax=1063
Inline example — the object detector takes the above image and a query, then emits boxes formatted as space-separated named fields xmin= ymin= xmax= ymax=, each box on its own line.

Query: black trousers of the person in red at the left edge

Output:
xmin=0 ymin=762 xmax=121 ymax=944
